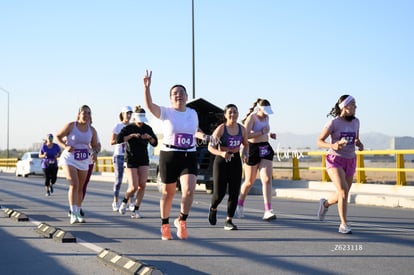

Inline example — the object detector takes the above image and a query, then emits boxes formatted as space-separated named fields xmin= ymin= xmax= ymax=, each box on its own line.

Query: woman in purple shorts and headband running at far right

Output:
xmin=317 ymin=95 xmax=364 ymax=234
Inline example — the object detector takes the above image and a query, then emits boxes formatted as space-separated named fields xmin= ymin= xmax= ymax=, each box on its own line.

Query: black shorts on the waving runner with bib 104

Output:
xmin=159 ymin=151 xmax=197 ymax=183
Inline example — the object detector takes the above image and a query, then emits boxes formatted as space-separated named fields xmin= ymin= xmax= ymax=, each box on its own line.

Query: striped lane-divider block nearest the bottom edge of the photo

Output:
xmin=97 ymin=248 xmax=164 ymax=275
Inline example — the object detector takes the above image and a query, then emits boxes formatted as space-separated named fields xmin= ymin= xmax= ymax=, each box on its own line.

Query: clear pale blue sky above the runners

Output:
xmin=0 ymin=0 xmax=414 ymax=150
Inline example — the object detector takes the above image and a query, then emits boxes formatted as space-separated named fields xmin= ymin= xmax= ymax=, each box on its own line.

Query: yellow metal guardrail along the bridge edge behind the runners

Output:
xmin=0 ymin=150 xmax=414 ymax=185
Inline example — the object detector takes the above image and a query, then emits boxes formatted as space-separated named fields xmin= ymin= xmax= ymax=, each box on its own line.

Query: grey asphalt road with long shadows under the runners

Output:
xmin=0 ymin=173 xmax=414 ymax=275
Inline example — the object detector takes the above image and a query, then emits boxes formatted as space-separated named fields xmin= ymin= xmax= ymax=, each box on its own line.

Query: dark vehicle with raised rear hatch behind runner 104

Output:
xmin=148 ymin=98 xmax=223 ymax=193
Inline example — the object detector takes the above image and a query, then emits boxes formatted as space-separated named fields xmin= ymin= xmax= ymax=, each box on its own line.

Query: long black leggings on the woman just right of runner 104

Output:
xmin=211 ymin=153 xmax=242 ymax=218
